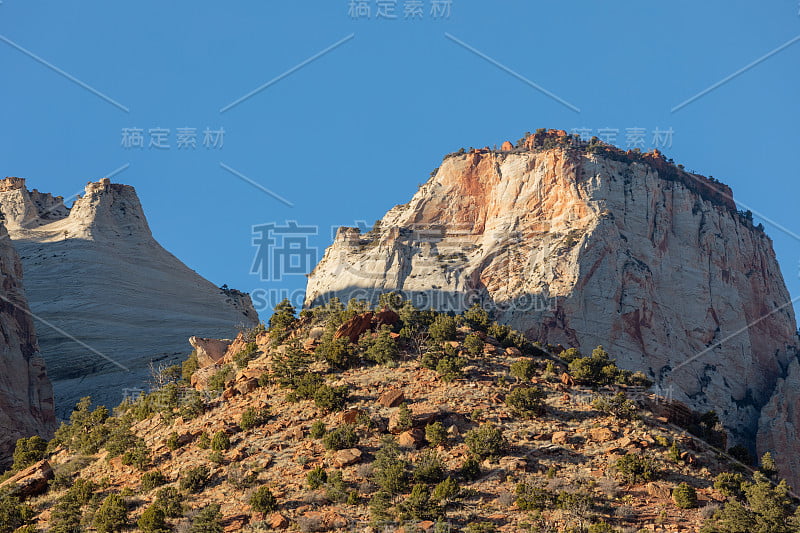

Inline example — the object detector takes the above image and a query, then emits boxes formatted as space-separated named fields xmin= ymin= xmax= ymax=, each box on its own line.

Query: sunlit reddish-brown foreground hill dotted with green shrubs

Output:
xmin=6 ymin=311 xmax=780 ymax=533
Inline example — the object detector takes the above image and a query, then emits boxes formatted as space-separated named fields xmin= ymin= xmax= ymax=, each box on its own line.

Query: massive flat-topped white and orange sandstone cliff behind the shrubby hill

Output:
xmin=306 ymin=132 xmax=797 ymax=482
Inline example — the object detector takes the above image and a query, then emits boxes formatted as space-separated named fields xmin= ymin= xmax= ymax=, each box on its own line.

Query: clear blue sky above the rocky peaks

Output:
xmin=0 ymin=0 xmax=800 ymax=317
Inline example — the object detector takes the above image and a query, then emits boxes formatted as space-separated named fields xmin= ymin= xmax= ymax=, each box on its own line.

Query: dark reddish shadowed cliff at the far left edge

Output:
xmin=0 ymin=218 xmax=55 ymax=466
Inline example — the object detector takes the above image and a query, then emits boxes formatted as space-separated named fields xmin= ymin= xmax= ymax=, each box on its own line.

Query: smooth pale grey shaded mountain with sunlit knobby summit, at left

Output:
xmin=0 ymin=178 xmax=258 ymax=418
